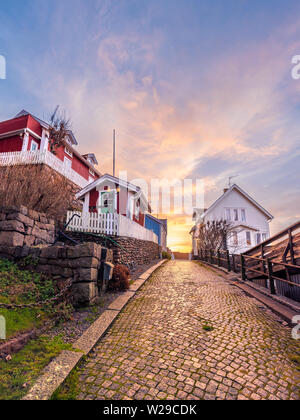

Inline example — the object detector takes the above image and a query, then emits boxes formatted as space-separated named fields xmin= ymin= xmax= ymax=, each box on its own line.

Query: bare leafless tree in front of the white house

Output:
xmin=197 ymin=220 xmax=232 ymax=251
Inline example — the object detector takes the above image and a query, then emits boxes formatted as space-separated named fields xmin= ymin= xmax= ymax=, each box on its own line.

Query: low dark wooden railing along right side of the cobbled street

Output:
xmin=199 ymin=248 xmax=300 ymax=302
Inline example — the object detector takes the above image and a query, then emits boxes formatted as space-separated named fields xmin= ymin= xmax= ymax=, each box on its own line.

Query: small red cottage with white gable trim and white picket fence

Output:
xmin=68 ymin=174 xmax=158 ymax=243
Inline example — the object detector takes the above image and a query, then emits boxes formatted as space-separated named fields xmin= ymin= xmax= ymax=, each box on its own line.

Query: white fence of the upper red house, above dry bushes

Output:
xmin=0 ymin=150 xmax=89 ymax=188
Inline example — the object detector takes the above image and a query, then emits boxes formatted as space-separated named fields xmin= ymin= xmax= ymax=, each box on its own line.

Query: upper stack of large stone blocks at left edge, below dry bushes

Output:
xmin=0 ymin=206 xmax=55 ymax=247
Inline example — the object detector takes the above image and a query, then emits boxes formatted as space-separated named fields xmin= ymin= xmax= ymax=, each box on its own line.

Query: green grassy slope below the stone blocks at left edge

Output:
xmin=0 ymin=259 xmax=55 ymax=338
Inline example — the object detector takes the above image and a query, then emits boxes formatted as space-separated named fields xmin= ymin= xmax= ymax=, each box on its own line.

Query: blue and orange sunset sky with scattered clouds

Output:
xmin=0 ymin=0 xmax=300 ymax=251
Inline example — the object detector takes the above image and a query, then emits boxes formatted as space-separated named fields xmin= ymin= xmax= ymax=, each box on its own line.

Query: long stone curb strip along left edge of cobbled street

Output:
xmin=22 ymin=260 xmax=166 ymax=401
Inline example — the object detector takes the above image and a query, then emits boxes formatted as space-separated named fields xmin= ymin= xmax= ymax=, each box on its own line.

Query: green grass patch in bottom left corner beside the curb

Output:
xmin=0 ymin=337 xmax=72 ymax=400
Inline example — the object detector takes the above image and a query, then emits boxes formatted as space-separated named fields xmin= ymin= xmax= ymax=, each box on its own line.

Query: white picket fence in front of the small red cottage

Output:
xmin=67 ymin=211 xmax=158 ymax=243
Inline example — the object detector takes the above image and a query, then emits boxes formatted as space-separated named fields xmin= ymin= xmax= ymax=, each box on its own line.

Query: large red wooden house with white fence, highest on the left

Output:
xmin=0 ymin=110 xmax=101 ymax=188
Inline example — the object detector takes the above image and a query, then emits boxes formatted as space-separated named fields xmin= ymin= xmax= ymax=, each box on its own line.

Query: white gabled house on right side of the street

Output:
xmin=191 ymin=184 xmax=274 ymax=256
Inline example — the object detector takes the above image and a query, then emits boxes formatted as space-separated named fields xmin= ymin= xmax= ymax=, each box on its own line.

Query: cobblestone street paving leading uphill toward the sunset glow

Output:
xmin=73 ymin=261 xmax=300 ymax=400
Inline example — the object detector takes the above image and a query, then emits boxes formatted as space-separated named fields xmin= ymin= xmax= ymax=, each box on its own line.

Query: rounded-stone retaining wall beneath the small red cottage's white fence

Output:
xmin=64 ymin=232 xmax=161 ymax=268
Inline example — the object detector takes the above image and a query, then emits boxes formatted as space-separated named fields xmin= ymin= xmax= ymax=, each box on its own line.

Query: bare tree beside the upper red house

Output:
xmin=49 ymin=106 xmax=71 ymax=154
